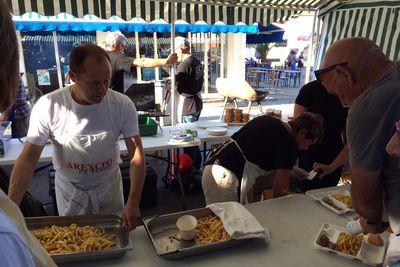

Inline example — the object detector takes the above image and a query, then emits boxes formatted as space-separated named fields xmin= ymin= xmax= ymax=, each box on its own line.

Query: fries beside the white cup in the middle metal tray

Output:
xmin=196 ymin=214 xmax=230 ymax=245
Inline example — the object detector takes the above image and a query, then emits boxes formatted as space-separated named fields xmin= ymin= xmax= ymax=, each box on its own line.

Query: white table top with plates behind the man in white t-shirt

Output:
xmin=0 ymin=126 xmax=241 ymax=166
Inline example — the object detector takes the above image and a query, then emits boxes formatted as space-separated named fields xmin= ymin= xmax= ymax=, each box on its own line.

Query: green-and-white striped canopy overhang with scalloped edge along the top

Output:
xmin=7 ymin=0 xmax=322 ymax=25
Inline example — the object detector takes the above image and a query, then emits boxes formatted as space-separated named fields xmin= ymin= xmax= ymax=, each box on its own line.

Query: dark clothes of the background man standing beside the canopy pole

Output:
xmin=175 ymin=55 xmax=204 ymax=115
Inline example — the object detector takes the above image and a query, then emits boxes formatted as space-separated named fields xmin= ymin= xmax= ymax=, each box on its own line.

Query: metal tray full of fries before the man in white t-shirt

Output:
xmin=25 ymin=215 xmax=132 ymax=263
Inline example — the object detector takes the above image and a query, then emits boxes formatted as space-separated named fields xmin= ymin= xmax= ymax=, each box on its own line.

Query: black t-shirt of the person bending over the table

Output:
xmin=207 ymin=115 xmax=298 ymax=179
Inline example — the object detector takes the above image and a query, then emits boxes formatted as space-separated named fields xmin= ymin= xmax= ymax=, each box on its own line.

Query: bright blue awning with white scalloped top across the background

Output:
xmin=13 ymin=12 xmax=259 ymax=33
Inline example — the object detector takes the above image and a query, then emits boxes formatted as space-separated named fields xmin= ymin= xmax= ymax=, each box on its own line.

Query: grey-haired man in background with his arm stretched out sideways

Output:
xmin=104 ymin=31 xmax=178 ymax=93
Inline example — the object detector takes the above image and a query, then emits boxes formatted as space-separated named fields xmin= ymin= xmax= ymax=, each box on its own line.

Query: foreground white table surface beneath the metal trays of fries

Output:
xmin=62 ymin=195 xmax=365 ymax=267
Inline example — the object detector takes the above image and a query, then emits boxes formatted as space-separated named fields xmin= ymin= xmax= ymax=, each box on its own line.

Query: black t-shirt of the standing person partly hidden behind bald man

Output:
xmin=295 ymin=81 xmax=347 ymax=164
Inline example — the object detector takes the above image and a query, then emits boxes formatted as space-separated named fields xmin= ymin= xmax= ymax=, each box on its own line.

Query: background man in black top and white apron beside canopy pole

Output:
xmin=175 ymin=37 xmax=204 ymax=175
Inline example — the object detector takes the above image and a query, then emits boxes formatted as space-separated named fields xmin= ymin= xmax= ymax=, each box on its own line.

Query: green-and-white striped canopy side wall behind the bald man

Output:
xmin=316 ymin=0 xmax=400 ymax=66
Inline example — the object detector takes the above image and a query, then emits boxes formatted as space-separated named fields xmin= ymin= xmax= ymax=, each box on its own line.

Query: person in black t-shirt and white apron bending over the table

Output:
xmin=202 ymin=112 xmax=324 ymax=205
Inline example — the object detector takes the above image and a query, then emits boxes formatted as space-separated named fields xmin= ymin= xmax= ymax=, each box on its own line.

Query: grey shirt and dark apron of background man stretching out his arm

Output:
xmin=107 ymin=51 xmax=134 ymax=93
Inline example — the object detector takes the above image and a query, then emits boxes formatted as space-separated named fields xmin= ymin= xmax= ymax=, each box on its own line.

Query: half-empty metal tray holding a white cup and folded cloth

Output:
xmin=143 ymin=208 xmax=251 ymax=259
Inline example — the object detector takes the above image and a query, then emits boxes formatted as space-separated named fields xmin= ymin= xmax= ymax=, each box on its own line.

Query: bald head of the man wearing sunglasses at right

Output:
xmin=319 ymin=38 xmax=393 ymax=106
